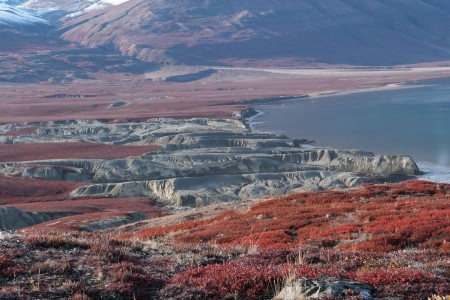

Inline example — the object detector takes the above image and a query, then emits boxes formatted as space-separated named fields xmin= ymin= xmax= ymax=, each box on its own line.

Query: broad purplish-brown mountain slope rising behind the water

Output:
xmin=62 ymin=0 xmax=450 ymax=65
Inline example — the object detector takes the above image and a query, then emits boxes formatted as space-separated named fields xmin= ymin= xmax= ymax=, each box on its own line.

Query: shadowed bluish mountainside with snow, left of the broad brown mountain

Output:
xmin=0 ymin=0 xmax=153 ymax=83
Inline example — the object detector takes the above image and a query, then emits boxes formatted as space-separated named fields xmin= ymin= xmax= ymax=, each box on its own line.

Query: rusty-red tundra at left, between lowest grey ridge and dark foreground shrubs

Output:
xmin=0 ymin=175 xmax=167 ymax=230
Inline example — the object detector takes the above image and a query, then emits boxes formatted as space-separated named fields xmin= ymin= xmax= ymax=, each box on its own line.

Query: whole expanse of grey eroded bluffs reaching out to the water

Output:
xmin=0 ymin=119 xmax=419 ymax=206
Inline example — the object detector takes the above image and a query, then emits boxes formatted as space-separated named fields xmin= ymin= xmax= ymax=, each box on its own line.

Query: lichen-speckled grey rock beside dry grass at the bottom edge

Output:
xmin=274 ymin=275 xmax=373 ymax=300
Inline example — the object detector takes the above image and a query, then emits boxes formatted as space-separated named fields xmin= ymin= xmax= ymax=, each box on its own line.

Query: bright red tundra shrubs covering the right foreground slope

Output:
xmin=130 ymin=181 xmax=450 ymax=299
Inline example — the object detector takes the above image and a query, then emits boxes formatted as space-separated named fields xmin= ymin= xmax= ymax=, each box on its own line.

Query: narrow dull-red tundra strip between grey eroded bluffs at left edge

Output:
xmin=0 ymin=142 xmax=160 ymax=162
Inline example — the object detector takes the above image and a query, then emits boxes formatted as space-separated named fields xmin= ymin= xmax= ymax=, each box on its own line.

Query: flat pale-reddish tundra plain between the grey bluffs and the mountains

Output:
xmin=0 ymin=67 xmax=448 ymax=123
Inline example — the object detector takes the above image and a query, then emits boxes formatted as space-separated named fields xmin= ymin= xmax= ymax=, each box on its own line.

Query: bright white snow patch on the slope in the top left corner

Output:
xmin=0 ymin=3 xmax=50 ymax=27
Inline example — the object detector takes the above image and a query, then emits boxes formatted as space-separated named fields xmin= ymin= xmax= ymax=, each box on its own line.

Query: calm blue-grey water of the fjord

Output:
xmin=252 ymin=79 xmax=450 ymax=182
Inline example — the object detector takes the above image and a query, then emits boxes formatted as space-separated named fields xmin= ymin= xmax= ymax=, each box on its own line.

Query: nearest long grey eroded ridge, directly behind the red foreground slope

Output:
xmin=71 ymin=171 xmax=369 ymax=207
